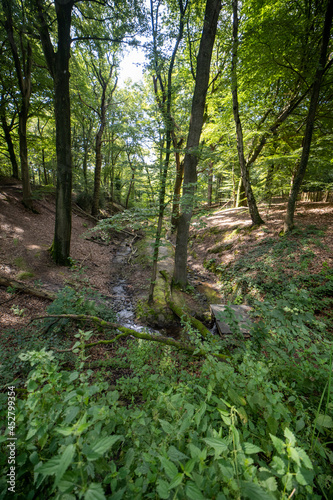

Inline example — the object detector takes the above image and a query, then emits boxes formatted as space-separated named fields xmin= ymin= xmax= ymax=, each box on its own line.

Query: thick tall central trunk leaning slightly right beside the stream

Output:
xmin=173 ymin=0 xmax=221 ymax=287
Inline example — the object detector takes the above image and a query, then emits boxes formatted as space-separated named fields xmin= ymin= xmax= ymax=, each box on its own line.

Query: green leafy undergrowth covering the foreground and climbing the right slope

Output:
xmin=0 ymin=225 xmax=333 ymax=500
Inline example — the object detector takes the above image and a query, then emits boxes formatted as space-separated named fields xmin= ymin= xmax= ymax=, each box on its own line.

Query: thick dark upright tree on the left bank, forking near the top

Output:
xmin=31 ymin=0 xmax=140 ymax=264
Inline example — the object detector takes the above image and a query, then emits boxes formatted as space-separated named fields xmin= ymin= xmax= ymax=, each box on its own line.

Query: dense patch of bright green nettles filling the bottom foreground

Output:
xmin=0 ymin=331 xmax=331 ymax=500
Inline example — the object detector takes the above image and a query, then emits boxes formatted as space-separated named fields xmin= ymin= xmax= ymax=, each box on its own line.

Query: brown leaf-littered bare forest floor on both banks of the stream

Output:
xmin=0 ymin=174 xmax=333 ymax=342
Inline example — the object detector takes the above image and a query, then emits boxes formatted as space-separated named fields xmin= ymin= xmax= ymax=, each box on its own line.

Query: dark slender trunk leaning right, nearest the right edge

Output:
xmin=284 ymin=0 xmax=333 ymax=232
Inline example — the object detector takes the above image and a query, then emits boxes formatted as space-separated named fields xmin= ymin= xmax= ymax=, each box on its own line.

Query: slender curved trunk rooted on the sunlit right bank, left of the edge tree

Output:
xmin=231 ymin=0 xmax=264 ymax=226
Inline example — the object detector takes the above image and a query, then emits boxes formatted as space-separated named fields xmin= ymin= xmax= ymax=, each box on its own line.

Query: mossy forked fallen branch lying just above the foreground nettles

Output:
xmin=31 ymin=314 xmax=230 ymax=362
